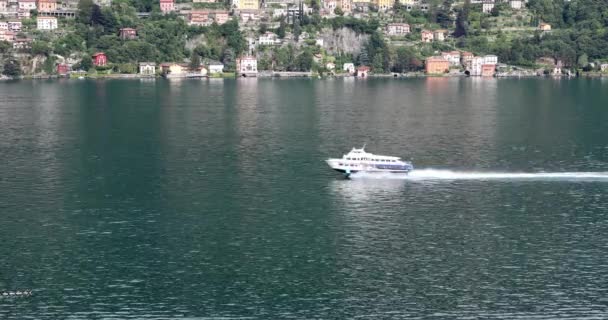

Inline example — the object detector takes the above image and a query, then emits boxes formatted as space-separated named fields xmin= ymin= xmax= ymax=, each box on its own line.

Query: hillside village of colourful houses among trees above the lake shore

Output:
xmin=0 ymin=0 xmax=608 ymax=78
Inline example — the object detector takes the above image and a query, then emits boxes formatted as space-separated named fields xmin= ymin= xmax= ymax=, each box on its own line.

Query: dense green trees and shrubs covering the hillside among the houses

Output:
xmin=0 ymin=0 xmax=608 ymax=75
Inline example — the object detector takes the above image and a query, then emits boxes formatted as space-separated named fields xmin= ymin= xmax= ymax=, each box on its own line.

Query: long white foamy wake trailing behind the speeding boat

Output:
xmin=351 ymin=169 xmax=608 ymax=182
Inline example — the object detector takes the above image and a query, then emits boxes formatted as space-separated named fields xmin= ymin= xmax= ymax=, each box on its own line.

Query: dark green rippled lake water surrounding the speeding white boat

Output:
xmin=0 ymin=79 xmax=608 ymax=319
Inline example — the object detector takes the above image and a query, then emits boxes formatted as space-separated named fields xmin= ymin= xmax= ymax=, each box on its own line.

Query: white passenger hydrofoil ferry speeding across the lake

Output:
xmin=325 ymin=146 xmax=414 ymax=177
